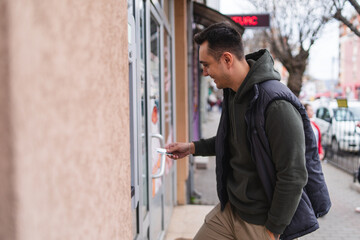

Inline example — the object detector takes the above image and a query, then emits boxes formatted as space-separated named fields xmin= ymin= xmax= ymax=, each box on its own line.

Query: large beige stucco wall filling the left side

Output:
xmin=0 ymin=0 xmax=132 ymax=240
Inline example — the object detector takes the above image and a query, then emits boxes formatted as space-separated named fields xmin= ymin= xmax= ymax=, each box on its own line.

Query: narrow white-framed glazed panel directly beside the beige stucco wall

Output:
xmin=128 ymin=0 xmax=151 ymax=240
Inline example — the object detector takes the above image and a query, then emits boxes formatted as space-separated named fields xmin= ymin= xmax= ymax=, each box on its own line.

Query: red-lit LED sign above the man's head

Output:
xmin=228 ymin=13 xmax=270 ymax=27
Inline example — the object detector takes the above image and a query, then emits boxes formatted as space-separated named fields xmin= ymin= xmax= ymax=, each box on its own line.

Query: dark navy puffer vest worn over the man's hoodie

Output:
xmin=245 ymin=80 xmax=331 ymax=240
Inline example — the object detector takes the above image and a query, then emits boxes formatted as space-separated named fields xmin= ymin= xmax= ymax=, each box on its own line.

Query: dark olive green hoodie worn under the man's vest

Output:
xmin=195 ymin=50 xmax=307 ymax=234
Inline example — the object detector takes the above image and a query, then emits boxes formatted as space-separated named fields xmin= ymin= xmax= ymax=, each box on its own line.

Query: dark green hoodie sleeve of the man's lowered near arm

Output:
xmin=265 ymin=100 xmax=307 ymax=234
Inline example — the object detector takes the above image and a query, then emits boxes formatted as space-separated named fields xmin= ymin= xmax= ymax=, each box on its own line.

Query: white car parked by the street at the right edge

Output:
xmin=314 ymin=101 xmax=360 ymax=152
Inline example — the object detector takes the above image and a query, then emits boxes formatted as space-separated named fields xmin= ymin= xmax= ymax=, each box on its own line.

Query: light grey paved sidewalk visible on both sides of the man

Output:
xmin=194 ymin=111 xmax=360 ymax=240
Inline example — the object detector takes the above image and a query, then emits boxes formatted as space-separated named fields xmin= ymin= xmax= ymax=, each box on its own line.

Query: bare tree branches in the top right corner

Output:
xmin=332 ymin=0 xmax=360 ymax=37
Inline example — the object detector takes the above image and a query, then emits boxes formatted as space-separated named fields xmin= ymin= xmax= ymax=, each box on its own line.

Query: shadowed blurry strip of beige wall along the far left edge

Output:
xmin=0 ymin=0 xmax=16 ymax=240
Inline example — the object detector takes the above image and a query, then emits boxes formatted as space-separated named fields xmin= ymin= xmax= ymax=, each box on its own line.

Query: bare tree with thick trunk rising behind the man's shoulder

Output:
xmin=250 ymin=0 xmax=332 ymax=96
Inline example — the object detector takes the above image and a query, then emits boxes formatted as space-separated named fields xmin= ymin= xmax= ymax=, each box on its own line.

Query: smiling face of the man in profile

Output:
xmin=199 ymin=41 xmax=227 ymax=89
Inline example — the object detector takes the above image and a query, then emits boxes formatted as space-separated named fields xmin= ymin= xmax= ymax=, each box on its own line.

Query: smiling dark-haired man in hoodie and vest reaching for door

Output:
xmin=166 ymin=23 xmax=330 ymax=240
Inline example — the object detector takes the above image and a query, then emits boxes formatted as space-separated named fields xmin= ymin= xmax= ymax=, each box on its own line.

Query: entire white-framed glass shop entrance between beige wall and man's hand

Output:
xmin=129 ymin=0 xmax=176 ymax=240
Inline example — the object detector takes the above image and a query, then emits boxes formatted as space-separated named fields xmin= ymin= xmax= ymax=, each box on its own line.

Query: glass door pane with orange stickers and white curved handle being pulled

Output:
xmin=148 ymin=8 xmax=166 ymax=239
